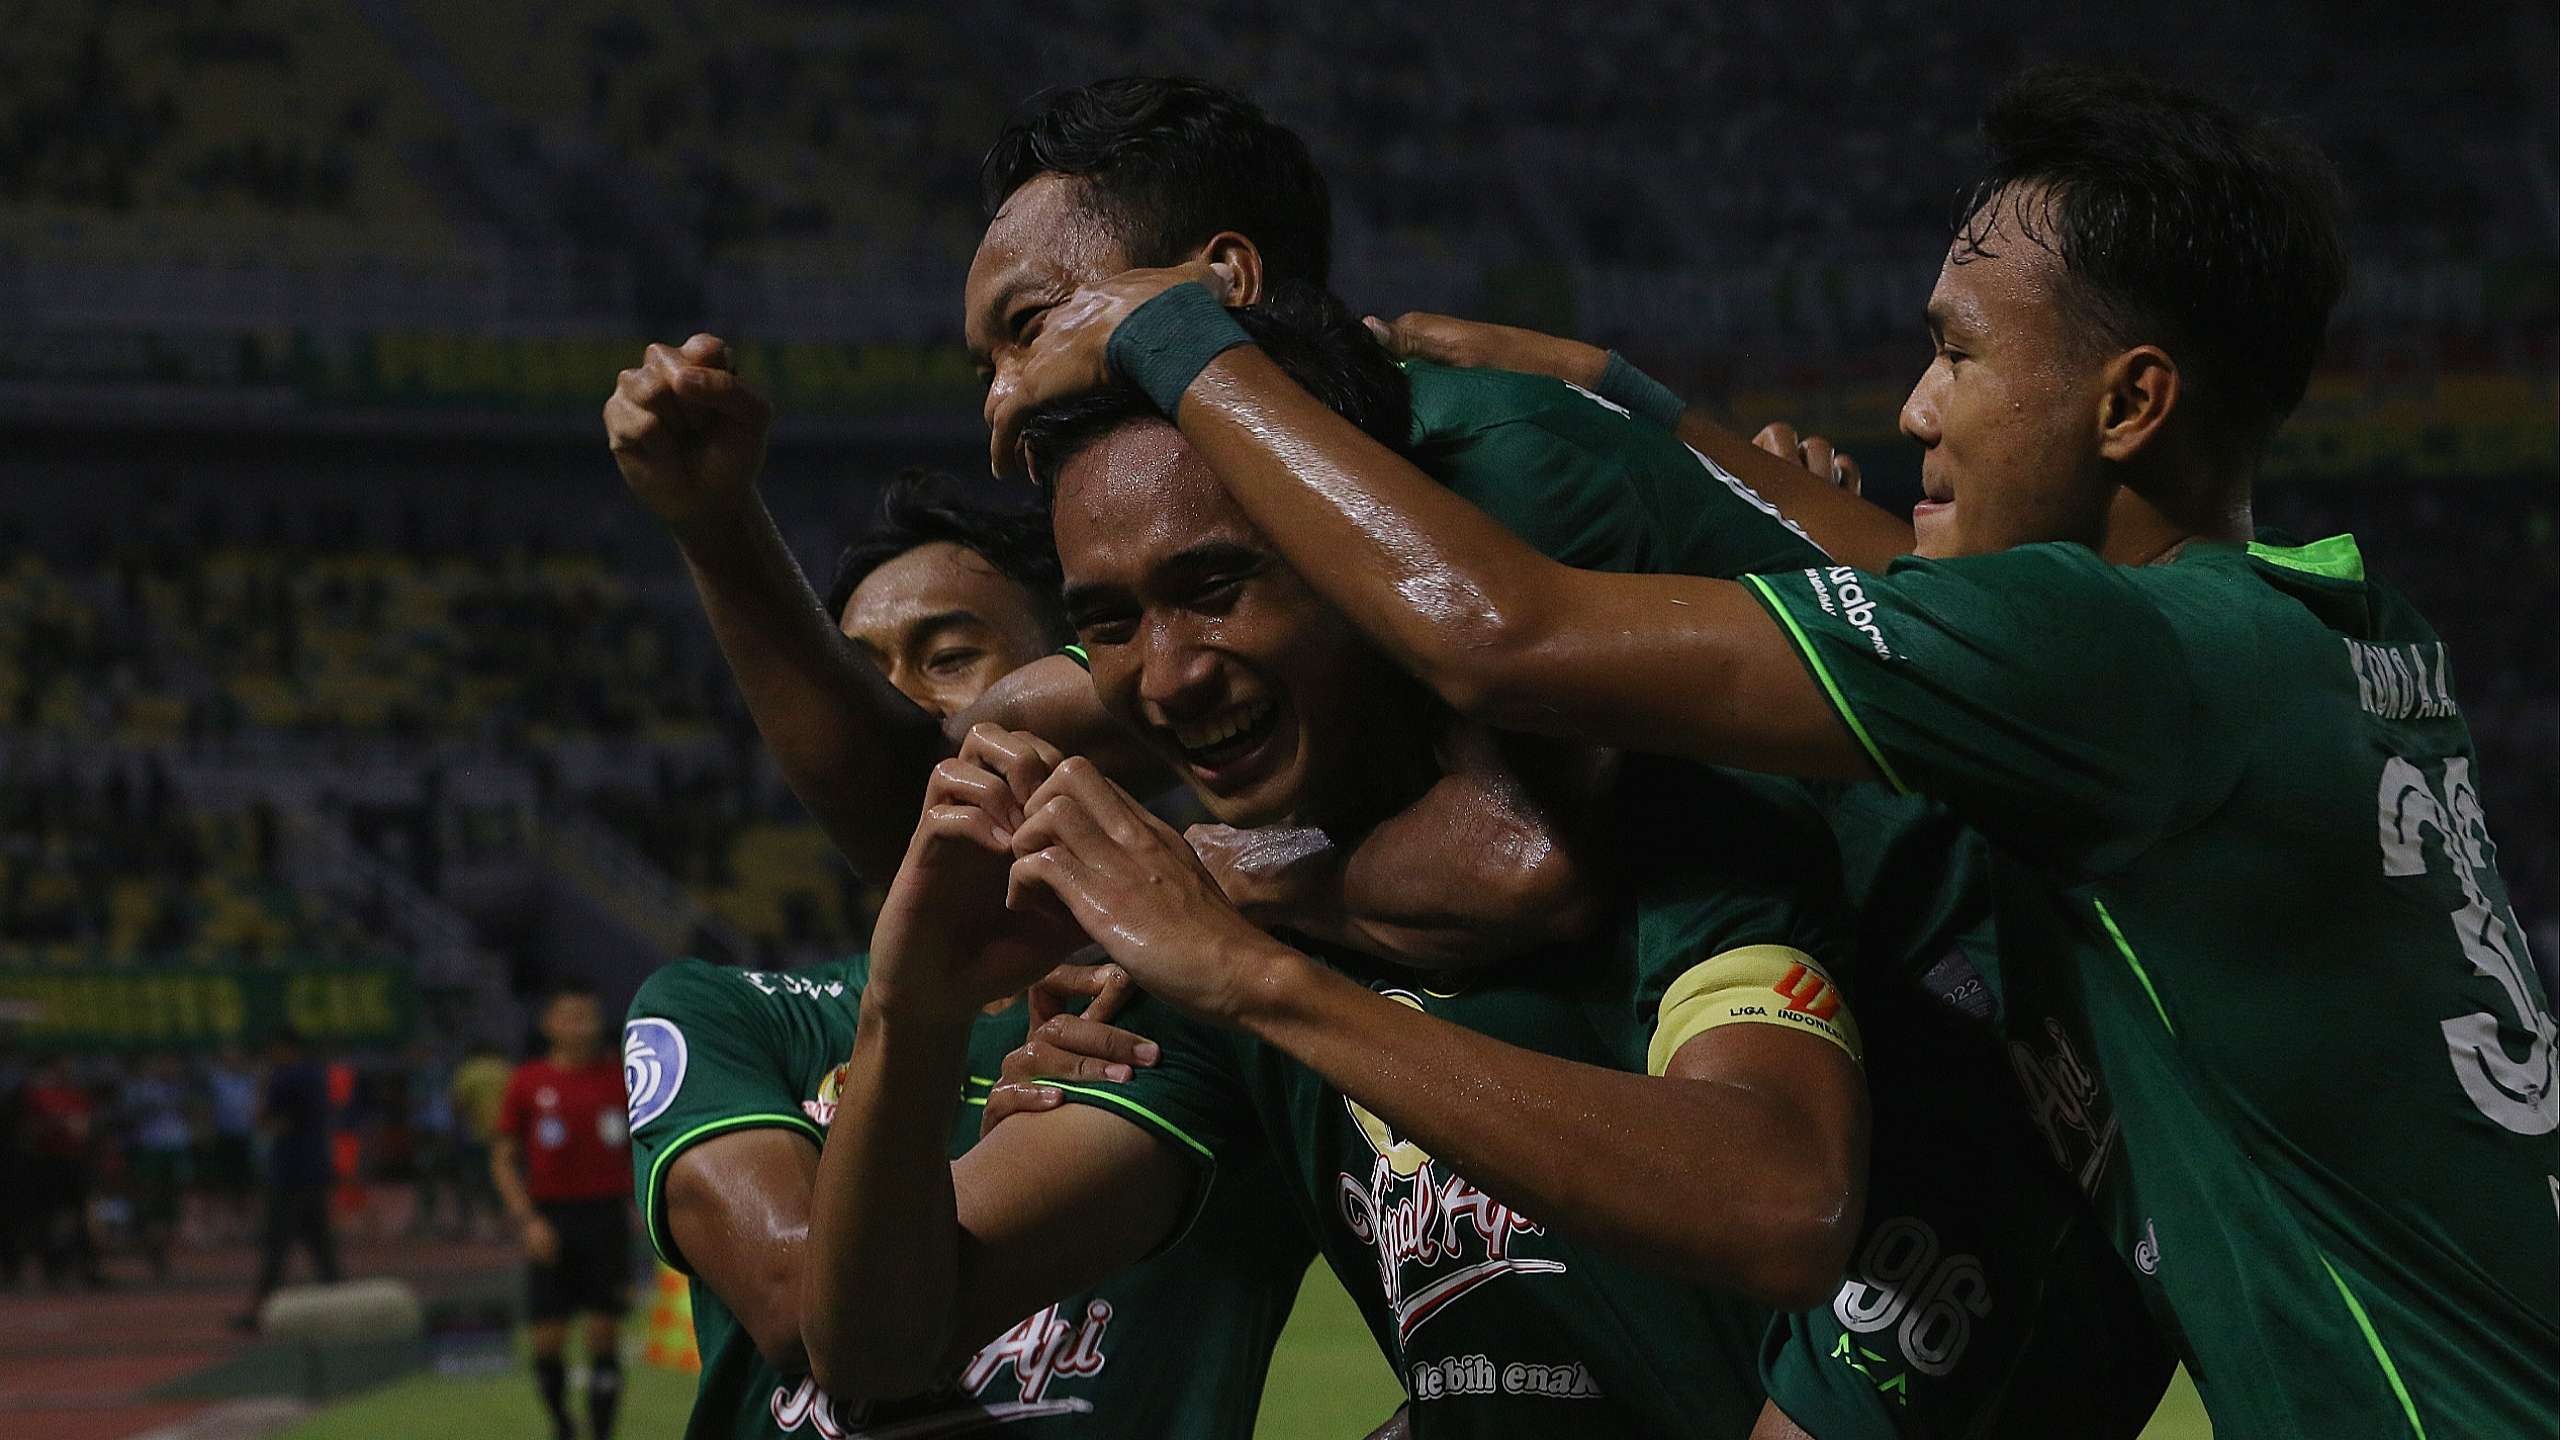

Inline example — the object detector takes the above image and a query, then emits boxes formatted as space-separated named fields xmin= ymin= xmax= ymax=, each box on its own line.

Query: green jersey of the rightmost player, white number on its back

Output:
xmin=1751 ymin=536 xmax=2560 ymax=1440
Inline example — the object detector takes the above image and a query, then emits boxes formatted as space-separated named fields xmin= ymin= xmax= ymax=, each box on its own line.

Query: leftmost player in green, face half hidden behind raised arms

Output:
xmin=622 ymin=471 xmax=1313 ymax=1440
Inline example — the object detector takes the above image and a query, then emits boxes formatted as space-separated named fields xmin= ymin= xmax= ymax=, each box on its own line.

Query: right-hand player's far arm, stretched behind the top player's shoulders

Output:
xmin=1372 ymin=310 xmax=1912 ymax=569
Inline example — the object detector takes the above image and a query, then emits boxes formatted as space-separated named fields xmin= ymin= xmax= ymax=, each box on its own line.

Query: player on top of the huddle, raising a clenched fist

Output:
xmin=607 ymin=77 xmax=1863 ymax=958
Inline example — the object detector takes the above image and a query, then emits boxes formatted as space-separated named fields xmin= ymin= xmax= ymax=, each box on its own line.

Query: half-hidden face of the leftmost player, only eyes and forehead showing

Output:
xmin=840 ymin=541 xmax=1052 ymax=720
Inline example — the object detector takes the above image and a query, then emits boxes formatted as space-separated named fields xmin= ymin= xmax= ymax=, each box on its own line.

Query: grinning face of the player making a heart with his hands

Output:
xmin=1055 ymin=420 xmax=1428 ymax=825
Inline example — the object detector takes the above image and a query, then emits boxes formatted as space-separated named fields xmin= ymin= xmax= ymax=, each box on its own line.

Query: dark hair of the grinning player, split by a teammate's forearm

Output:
xmin=1021 ymin=284 xmax=1413 ymax=495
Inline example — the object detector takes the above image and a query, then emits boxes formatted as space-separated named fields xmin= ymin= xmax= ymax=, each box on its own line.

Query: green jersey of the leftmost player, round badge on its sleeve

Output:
xmin=622 ymin=956 xmax=1313 ymax=1440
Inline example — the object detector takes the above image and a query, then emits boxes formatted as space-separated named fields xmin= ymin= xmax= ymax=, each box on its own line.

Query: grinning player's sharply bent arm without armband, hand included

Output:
xmin=801 ymin=758 xmax=1196 ymax=1399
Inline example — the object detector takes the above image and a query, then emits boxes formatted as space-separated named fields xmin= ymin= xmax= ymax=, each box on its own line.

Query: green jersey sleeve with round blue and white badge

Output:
xmin=622 ymin=961 xmax=824 ymax=1273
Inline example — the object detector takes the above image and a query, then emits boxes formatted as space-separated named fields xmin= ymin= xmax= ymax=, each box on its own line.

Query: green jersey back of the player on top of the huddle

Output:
xmin=1405 ymin=361 xmax=1823 ymax=579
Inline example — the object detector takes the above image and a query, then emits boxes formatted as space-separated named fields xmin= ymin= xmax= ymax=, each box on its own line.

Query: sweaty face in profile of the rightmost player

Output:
xmin=1902 ymin=197 xmax=2115 ymax=559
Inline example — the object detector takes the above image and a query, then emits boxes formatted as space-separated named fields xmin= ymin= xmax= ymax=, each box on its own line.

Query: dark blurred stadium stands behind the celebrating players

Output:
xmin=0 ymin=0 xmax=2560 ymax=1048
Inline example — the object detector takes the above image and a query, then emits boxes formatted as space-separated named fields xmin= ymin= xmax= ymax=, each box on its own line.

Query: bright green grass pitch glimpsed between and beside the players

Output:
xmin=284 ymin=1268 xmax=2212 ymax=1440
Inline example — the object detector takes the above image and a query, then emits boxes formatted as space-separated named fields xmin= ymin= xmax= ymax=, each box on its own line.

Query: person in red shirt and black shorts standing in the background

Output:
xmin=489 ymin=981 xmax=632 ymax=1440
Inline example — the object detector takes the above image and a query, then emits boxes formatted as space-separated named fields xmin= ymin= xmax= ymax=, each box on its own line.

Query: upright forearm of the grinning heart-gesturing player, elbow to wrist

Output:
xmin=801 ymin=997 xmax=968 ymax=1399
